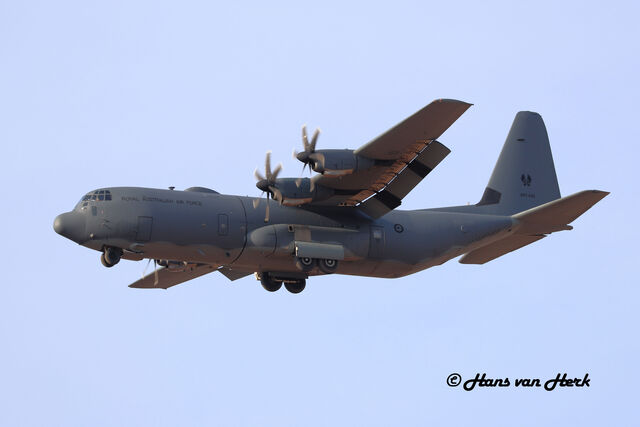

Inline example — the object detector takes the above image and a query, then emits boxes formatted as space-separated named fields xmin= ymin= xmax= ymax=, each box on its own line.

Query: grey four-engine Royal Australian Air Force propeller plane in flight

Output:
xmin=53 ymin=99 xmax=609 ymax=293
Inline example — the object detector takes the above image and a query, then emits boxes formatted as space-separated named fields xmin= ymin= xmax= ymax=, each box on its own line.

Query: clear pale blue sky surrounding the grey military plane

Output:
xmin=0 ymin=0 xmax=640 ymax=426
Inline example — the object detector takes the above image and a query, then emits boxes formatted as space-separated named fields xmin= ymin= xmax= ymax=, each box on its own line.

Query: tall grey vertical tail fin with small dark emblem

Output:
xmin=478 ymin=111 xmax=560 ymax=215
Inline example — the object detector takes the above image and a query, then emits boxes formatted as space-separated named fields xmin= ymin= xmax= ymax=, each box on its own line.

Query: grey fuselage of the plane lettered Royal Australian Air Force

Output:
xmin=54 ymin=187 xmax=515 ymax=278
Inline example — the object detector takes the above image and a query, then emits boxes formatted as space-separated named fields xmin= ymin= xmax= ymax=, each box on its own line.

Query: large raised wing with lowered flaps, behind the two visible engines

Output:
xmin=312 ymin=99 xmax=471 ymax=218
